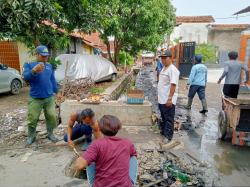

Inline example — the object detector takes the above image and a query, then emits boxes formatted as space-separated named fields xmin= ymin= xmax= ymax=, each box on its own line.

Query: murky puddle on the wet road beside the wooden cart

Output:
xmin=179 ymin=101 xmax=250 ymax=184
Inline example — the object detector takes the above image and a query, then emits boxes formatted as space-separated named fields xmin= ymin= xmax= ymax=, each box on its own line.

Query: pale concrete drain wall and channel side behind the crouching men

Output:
xmin=61 ymin=69 xmax=152 ymax=126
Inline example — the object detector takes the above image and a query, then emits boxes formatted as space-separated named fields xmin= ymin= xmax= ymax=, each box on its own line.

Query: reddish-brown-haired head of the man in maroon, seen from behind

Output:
xmin=99 ymin=115 xmax=122 ymax=136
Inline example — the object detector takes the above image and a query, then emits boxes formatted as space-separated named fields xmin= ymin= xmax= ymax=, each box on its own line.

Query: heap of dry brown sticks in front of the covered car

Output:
xmin=60 ymin=77 xmax=95 ymax=100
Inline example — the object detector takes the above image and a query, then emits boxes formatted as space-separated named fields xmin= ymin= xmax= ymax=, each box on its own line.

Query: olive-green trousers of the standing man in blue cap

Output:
xmin=27 ymin=96 xmax=57 ymax=129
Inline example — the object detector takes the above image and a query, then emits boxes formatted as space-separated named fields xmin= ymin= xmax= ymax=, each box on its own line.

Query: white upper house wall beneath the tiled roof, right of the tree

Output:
xmin=170 ymin=23 xmax=208 ymax=44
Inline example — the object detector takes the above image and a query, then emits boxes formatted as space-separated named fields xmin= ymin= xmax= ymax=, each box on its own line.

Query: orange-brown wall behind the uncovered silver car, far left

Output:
xmin=0 ymin=41 xmax=20 ymax=71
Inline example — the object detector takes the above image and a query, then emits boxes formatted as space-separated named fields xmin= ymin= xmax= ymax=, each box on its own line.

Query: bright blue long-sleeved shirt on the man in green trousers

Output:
xmin=23 ymin=62 xmax=58 ymax=99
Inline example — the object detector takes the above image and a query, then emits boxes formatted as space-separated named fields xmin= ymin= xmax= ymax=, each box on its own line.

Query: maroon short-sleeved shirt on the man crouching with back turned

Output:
xmin=83 ymin=136 xmax=136 ymax=187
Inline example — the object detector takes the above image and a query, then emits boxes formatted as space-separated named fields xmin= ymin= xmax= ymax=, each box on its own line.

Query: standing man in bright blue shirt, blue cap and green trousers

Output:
xmin=23 ymin=45 xmax=58 ymax=145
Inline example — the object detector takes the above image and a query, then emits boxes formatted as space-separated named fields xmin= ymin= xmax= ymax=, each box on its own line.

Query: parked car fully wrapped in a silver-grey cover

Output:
xmin=55 ymin=54 xmax=117 ymax=82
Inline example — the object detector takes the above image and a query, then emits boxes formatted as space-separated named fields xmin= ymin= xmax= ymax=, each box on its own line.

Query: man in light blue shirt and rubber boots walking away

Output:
xmin=186 ymin=55 xmax=208 ymax=114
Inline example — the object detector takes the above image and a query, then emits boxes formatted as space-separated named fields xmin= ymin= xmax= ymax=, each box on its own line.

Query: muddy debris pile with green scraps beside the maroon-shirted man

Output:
xmin=138 ymin=150 xmax=205 ymax=187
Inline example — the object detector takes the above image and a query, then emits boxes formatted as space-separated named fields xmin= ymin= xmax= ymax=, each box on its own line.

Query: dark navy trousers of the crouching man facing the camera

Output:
xmin=64 ymin=123 xmax=92 ymax=142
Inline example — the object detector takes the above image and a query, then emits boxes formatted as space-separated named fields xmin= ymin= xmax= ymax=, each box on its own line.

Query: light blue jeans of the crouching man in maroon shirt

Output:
xmin=87 ymin=156 xmax=138 ymax=187
